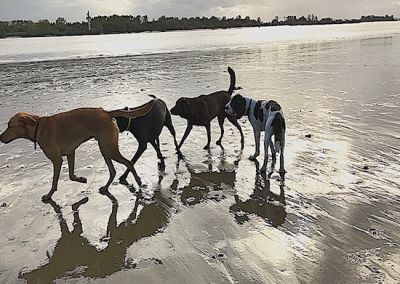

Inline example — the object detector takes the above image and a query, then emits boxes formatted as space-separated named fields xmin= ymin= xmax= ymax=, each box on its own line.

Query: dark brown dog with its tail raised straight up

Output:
xmin=171 ymin=67 xmax=244 ymax=149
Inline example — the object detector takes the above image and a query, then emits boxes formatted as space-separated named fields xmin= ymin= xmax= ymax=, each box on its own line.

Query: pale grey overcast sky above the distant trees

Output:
xmin=0 ymin=0 xmax=400 ymax=21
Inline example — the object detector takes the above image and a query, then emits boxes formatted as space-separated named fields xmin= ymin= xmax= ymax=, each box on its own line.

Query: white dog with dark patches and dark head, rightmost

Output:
xmin=225 ymin=94 xmax=286 ymax=175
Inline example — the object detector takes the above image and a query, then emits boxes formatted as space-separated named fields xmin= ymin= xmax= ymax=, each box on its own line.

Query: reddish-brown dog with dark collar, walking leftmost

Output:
xmin=0 ymin=101 xmax=154 ymax=201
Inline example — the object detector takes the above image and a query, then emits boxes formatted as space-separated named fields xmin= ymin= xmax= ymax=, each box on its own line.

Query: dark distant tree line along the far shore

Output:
xmin=0 ymin=15 xmax=394 ymax=38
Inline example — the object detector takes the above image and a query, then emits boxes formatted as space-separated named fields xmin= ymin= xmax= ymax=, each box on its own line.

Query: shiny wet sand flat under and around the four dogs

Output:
xmin=0 ymin=28 xmax=400 ymax=283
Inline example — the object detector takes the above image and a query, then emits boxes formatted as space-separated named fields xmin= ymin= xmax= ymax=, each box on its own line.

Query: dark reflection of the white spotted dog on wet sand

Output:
xmin=229 ymin=161 xmax=286 ymax=227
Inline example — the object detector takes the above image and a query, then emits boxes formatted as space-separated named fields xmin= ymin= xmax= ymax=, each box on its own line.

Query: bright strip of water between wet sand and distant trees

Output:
xmin=0 ymin=23 xmax=400 ymax=66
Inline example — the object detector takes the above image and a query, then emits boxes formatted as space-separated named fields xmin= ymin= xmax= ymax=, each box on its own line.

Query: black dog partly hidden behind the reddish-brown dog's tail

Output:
xmin=115 ymin=95 xmax=182 ymax=183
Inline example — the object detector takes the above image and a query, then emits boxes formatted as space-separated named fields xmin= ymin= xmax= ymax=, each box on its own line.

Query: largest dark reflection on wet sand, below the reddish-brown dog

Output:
xmin=20 ymin=182 xmax=170 ymax=283
